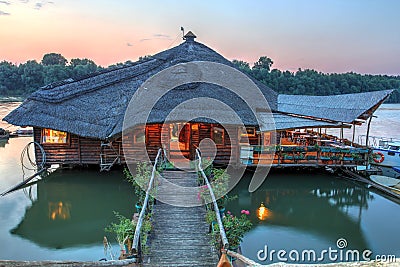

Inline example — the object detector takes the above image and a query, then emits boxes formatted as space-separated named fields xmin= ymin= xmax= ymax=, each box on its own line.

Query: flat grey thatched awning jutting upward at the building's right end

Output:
xmin=278 ymin=90 xmax=393 ymax=123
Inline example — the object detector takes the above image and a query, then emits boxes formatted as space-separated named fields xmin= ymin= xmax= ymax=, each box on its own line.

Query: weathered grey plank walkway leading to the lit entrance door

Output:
xmin=143 ymin=171 xmax=218 ymax=267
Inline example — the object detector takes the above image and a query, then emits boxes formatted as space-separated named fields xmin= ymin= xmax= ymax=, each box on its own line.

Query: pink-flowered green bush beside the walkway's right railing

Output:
xmin=212 ymin=210 xmax=252 ymax=250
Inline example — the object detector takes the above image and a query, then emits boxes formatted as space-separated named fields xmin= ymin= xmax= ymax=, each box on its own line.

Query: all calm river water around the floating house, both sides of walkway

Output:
xmin=0 ymin=103 xmax=400 ymax=264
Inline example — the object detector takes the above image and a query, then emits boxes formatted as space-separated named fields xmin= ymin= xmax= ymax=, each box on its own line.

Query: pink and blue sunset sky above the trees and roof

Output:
xmin=0 ymin=0 xmax=400 ymax=75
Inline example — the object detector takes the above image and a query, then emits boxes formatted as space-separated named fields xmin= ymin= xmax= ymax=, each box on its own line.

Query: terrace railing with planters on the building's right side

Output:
xmin=240 ymin=144 xmax=370 ymax=166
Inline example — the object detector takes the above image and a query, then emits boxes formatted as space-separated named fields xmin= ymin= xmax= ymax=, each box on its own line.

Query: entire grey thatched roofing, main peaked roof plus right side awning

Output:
xmin=4 ymin=33 xmax=391 ymax=139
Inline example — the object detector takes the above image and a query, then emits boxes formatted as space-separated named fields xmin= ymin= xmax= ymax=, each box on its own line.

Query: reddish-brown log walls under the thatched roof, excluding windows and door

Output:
xmin=34 ymin=123 xmax=245 ymax=168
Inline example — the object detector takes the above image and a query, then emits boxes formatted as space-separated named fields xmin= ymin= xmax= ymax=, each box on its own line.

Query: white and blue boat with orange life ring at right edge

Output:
xmin=371 ymin=138 xmax=400 ymax=178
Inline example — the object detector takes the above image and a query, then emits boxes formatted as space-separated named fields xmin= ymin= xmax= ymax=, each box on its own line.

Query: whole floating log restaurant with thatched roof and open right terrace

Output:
xmin=4 ymin=32 xmax=392 ymax=170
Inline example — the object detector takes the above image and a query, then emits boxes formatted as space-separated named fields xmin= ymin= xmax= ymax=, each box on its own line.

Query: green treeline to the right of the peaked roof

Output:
xmin=233 ymin=57 xmax=400 ymax=103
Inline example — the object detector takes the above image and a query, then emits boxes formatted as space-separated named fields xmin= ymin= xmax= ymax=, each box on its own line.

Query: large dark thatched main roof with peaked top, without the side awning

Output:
xmin=4 ymin=38 xmax=278 ymax=139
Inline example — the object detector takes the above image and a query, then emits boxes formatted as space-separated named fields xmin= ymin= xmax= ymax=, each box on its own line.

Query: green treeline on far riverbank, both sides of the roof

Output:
xmin=0 ymin=53 xmax=400 ymax=103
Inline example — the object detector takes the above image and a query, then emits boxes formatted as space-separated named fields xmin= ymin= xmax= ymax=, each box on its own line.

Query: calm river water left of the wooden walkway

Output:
xmin=0 ymin=103 xmax=136 ymax=260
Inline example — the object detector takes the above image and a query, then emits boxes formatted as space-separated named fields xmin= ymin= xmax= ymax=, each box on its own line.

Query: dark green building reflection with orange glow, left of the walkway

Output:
xmin=11 ymin=170 xmax=136 ymax=248
